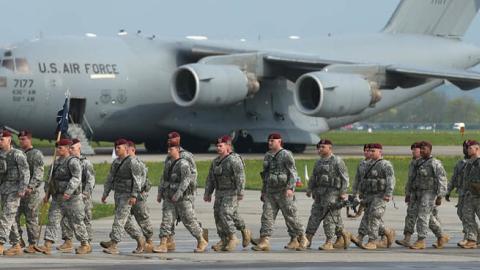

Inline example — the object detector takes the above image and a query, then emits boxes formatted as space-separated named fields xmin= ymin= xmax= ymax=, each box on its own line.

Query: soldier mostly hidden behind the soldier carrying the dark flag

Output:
xmin=57 ymin=139 xmax=95 ymax=253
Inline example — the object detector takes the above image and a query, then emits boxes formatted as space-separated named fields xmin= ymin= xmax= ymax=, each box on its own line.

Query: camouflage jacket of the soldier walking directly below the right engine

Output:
xmin=307 ymin=155 xmax=349 ymax=195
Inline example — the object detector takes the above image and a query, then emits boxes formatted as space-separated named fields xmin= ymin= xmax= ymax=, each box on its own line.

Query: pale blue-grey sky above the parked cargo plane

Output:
xmin=0 ymin=0 xmax=480 ymax=45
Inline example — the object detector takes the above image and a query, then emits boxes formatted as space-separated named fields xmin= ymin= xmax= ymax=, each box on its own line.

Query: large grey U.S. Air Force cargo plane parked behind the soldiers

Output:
xmin=0 ymin=0 xmax=480 ymax=152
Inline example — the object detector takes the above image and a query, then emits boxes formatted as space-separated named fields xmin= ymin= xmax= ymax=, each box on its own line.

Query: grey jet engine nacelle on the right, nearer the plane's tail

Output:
xmin=294 ymin=71 xmax=381 ymax=117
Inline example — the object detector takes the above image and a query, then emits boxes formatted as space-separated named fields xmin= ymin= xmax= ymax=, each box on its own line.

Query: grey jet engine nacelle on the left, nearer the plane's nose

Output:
xmin=171 ymin=64 xmax=260 ymax=107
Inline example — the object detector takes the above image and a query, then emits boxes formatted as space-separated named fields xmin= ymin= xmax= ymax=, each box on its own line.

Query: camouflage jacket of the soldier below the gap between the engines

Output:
xmin=260 ymin=149 xmax=298 ymax=193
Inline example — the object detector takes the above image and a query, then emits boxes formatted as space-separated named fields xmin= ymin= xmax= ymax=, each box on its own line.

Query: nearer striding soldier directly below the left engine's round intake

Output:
xmin=153 ymin=139 xmax=208 ymax=253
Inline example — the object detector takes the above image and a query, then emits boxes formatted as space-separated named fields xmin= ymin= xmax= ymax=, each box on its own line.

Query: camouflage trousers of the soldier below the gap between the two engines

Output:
xmin=260 ymin=191 xmax=304 ymax=237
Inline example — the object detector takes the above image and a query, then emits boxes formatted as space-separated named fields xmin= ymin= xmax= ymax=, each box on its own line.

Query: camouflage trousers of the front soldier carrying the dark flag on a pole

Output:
xmin=44 ymin=194 xmax=88 ymax=242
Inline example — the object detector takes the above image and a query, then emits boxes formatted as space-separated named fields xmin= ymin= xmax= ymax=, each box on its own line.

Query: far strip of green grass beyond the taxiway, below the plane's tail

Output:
xmin=320 ymin=130 xmax=480 ymax=147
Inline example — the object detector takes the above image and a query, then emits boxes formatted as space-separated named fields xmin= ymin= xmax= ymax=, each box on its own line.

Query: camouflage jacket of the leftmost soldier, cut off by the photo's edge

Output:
xmin=0 ymin=148 xmax=30 ymax=194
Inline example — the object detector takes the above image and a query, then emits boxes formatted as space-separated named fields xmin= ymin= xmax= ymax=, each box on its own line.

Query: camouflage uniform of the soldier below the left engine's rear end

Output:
xmin=205 ymin=153 xmax=245 ymax=242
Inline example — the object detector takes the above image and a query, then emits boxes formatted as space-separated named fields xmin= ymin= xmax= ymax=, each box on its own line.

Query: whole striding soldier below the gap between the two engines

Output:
xmin=252 ymin=133 xmax=309 ymax=251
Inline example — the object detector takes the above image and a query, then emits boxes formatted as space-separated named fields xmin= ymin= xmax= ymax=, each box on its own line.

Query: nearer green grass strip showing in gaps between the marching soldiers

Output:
xmin=90 ymin=157 xmax=460 ymax=195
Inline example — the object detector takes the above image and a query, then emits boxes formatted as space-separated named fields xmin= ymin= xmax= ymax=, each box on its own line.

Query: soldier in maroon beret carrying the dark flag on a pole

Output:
xmin=35 ymin=139 xmax=92 ymax=255
